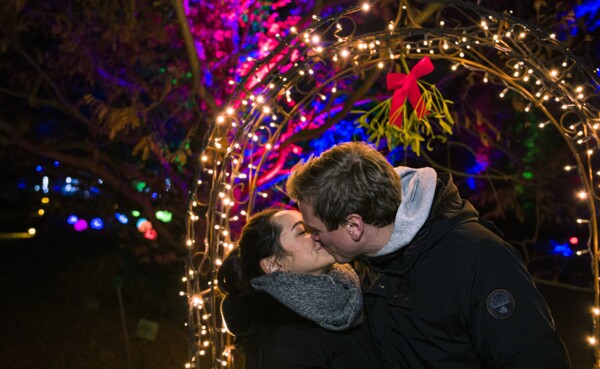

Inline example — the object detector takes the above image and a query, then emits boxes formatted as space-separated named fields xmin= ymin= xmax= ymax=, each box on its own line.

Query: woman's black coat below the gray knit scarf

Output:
xmin=221 ymin=291 xmax=382 ymax=369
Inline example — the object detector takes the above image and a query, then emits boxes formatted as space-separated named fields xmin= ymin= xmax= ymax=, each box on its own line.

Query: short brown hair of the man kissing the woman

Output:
xmin=286 ymin=142 xmax=402 ymax=231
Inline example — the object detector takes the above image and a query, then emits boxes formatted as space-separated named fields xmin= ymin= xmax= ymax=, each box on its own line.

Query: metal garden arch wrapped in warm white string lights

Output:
xmin=184 ymin=1 xmax=600 ymax=368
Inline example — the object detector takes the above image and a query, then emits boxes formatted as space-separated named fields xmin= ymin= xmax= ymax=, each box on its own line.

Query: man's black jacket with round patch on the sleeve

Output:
xmin=363 ymin=175 xmax=571 ymax=369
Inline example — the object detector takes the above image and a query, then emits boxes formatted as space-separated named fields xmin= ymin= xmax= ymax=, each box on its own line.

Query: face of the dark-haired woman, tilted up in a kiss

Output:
xmin=272 ymin=210 xmax=335 ymax=275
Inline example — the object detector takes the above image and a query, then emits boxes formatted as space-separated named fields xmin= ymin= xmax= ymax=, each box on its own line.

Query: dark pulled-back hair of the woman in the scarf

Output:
xmin=217 ymin=208 xmax=287 ymax=294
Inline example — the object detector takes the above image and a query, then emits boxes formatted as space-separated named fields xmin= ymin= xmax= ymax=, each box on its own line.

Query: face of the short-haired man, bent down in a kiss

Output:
xmin=298 ymin=203 xmax=360 ymax=263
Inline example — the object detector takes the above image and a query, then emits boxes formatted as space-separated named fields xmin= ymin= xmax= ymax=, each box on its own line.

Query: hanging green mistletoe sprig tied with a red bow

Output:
xmin=353 ymin=57 xmax=454 ymax=155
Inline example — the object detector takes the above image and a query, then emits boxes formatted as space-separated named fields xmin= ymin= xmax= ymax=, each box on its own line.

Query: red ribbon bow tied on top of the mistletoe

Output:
xmin=387 ymin=56 xmax=433 ymax=127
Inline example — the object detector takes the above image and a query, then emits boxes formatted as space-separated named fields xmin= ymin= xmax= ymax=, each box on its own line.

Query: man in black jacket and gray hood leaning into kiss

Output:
xmin=286 ymin=142 xmax=571 ymax=369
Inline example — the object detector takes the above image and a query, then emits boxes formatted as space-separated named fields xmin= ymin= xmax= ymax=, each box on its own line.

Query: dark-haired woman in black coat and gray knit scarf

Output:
xmin=218 ymin=209 xmax=381 ymax=369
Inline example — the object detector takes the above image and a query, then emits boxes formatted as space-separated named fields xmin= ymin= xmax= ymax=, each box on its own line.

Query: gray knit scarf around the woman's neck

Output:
xmin=250 ymin=264 xmax=362 ymax=331
